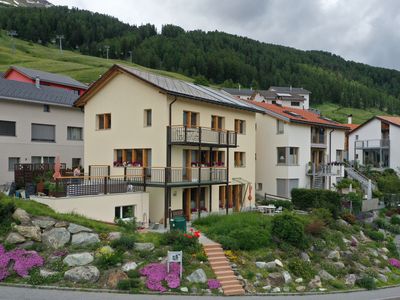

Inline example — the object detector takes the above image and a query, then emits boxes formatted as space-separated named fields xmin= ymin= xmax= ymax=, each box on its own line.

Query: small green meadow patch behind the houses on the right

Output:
xmin=311 ymin=99 xmax=387 ymax=124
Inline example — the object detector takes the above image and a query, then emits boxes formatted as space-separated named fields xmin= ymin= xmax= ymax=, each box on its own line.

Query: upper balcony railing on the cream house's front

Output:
xmin=167 ymin=125 xmax=238 ymax=148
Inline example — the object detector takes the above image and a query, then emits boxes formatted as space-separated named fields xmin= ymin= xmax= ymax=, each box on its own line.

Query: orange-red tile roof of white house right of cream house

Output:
xmin=251 ymin=101 xmax=348 ymax=130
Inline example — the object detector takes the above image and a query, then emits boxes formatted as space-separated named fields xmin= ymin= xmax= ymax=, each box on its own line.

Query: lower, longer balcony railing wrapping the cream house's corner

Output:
xmin=125 ymin=167 xmax=227 ymax=187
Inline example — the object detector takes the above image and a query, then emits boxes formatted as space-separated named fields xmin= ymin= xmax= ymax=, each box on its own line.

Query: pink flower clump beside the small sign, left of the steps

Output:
xmin=139 ymin=263 xmax=181 ymax=293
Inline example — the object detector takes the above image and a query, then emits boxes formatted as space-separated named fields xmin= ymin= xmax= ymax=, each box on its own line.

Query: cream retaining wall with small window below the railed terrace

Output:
xmin=31 ymin=192 xmax=149 ymax=224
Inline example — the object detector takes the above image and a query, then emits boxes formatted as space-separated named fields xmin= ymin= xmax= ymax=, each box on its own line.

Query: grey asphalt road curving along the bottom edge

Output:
xmin=0 ymin=286 xmax=400 ymax=300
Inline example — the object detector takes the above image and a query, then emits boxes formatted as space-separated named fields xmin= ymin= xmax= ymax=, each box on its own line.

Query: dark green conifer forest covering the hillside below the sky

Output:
xmin=0 ymin=7 xmax=400 ymax=114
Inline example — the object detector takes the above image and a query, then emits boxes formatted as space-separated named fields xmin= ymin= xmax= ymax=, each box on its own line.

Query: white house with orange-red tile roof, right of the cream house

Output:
xmin=253 ymin=101 xmax=348 ymax=198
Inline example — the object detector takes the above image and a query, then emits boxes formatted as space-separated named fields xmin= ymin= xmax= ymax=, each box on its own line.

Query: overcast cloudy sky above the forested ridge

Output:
xmin=49 ymin=0 xmax=400 ymax=70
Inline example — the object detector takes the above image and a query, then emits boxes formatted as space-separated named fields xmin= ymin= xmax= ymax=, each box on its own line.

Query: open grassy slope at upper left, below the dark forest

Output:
xmin=0 ymin=31 xmax=193 ymax=83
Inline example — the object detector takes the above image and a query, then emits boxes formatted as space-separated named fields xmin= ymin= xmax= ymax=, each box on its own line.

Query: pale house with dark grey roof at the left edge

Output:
xmin=0 ymin=78 xmax=83 ymax=185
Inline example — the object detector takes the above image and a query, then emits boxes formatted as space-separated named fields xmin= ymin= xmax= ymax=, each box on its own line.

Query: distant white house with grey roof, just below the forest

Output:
xmin=252 ymin=86 xmax=311 ymax=109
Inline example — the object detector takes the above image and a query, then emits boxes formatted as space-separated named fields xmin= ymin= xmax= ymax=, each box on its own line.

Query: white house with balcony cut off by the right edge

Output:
xmin=349 ymin=116 xmax=400 ymax=172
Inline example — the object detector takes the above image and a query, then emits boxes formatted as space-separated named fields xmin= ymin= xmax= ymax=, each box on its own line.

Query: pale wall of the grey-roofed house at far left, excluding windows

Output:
xmin=0 ymin=100 xmax=85 ymax=184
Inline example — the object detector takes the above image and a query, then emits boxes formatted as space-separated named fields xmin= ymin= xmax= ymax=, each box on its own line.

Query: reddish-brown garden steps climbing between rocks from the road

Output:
xmin=203 ymin=243 xmax=245 ymax=296
